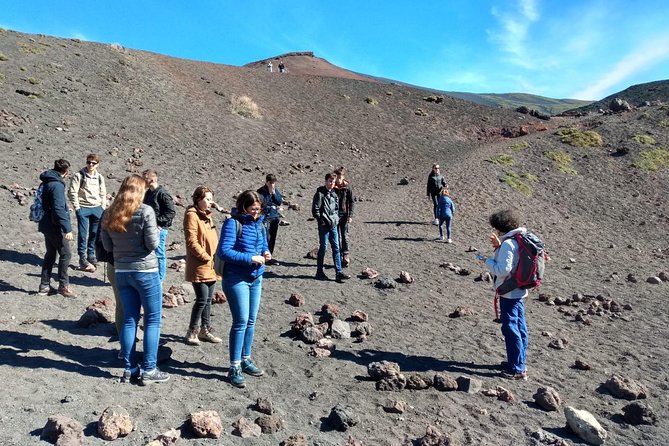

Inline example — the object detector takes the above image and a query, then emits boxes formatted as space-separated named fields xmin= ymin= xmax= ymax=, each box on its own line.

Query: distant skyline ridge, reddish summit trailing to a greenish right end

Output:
xmin=244 ymin=51 xmax=590 ymax=115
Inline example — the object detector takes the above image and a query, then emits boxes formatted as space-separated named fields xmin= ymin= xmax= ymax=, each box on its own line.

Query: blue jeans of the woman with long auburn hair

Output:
xmin=116 ymin=272 xmax=163 ymax=371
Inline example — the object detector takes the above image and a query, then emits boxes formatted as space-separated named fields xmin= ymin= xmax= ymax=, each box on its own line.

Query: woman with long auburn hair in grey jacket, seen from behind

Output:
xmin=102 ymin=175 xmax=170 ymax=385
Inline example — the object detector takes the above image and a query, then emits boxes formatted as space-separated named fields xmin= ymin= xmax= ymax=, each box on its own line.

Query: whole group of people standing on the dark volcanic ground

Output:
xmin=38 ymin=154 xmax=528 ymax=387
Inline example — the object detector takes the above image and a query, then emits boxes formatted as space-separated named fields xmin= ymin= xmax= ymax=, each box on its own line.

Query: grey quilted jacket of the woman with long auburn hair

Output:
xmin=102 ymin=204 xmax=160 ymax=271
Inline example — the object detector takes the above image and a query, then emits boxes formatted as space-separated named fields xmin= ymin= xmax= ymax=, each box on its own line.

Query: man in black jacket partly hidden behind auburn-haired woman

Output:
xmin=142 ymin=169 xmax=177 ymax=282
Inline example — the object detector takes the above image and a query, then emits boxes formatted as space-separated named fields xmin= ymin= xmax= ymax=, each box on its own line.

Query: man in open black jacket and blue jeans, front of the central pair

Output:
xmin=311 ymin=172 xmax=351 ymax=282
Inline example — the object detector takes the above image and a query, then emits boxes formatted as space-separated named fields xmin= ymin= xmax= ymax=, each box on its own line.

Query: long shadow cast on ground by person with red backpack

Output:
xmin=331 ymin=349 xmax=498 ymax=377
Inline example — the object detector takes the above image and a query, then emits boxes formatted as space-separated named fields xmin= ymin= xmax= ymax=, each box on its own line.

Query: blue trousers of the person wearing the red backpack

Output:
xmin=499 ymin=297 xmax=528 ymax=373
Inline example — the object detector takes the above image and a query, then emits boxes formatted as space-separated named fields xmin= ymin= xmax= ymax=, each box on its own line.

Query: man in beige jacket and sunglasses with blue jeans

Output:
xmin=67 ymin=153 xmax=107 ymax=273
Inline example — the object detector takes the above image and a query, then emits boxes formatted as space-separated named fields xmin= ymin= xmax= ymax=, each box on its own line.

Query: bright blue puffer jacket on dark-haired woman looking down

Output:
xmin=217 ymin=214 xmax=269 ymax=281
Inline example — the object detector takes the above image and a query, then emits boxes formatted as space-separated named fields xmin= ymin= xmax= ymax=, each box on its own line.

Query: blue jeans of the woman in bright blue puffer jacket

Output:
xmin=223 ymin=273 xmax=262 ymax=363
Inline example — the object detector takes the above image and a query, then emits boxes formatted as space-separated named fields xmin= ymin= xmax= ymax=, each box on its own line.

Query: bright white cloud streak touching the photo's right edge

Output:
xmin=571 ymin=34 xmax=669 ymax=100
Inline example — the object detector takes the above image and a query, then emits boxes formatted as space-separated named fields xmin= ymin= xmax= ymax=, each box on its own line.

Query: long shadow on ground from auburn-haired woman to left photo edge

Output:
xmin=0 ymin=330 xmax=116 ymax=378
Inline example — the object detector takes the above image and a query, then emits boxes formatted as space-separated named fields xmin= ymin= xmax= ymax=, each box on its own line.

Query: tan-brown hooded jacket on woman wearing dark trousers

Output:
xmin=184 ymin=206 xmax=218 ymax=282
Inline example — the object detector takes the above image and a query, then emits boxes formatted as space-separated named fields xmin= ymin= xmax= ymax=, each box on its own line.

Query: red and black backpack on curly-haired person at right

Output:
xmin=497 ymin=231 xmax=546 ymax=295
